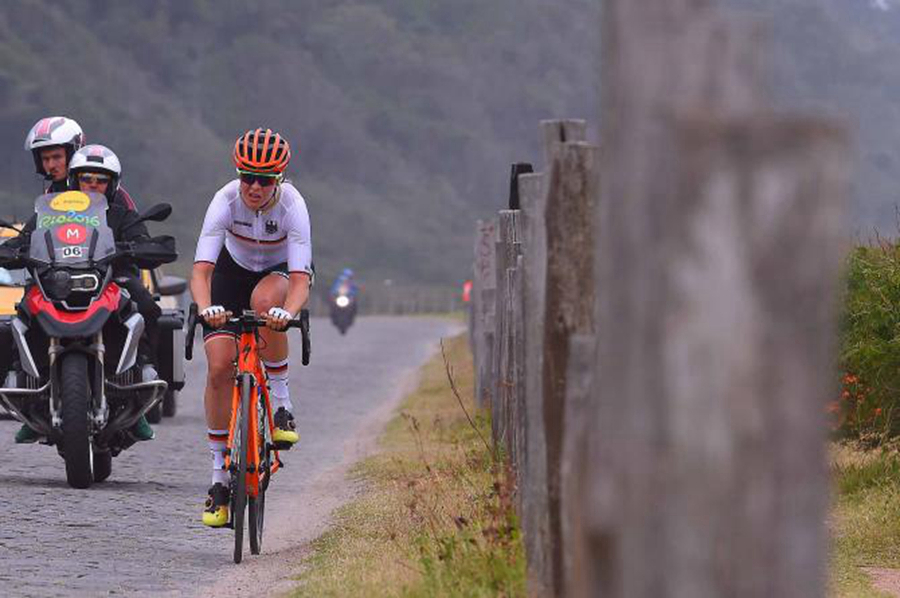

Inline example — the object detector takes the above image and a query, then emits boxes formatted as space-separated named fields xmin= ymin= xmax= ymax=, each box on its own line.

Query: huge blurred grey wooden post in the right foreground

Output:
xmin=568 ymin=0 xmax=849 ymax=598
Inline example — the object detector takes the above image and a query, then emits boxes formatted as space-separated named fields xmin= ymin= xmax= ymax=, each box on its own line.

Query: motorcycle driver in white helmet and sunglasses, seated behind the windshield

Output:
xmin=7 ymin=145 xmax=162 ymax=444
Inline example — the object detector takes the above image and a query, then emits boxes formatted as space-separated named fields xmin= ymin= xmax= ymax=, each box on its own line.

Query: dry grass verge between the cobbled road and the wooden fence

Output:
xmin=294 ymin=336 xmax=525 ymax=597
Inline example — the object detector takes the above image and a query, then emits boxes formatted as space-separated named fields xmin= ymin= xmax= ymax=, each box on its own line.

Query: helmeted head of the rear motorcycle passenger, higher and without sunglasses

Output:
xmin=25 ymin=116 xmax=84 ymax=193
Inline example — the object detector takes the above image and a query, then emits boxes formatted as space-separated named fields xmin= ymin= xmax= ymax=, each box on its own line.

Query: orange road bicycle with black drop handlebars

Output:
xmin=185 ymin=304 xmax=310 ymax=563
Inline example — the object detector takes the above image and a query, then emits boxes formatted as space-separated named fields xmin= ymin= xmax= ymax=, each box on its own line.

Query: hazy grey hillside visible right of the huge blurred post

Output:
xmin=728 ymin=0 xmax=900 ymax=230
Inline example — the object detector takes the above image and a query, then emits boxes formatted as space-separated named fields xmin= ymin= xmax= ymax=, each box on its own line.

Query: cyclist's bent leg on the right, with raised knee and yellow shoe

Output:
xmin=250 ymin=272 xmax=300 ymax=444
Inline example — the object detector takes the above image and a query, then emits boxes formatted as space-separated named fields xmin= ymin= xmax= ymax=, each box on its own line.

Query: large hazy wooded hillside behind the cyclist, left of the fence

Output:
xmin=0 ymin=0 xmax=598 ymax=284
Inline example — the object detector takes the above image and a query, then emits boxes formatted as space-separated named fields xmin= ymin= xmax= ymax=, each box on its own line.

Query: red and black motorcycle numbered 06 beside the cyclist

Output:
xmin=0 ymin=191 xmax=177 ymax=488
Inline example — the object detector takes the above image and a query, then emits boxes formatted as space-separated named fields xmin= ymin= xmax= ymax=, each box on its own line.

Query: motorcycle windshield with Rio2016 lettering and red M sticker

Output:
xmin=30 ymin=191 xmax=116 ymax=267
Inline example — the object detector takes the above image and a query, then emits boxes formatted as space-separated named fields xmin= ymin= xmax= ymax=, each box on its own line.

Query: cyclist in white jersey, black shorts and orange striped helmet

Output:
xmin=191 ymin=128 xmax=313 ymax=527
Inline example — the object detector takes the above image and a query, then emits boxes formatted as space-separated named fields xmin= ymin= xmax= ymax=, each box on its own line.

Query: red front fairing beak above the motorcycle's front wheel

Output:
xmin=25 ymin=282 xmax=129 ymax=338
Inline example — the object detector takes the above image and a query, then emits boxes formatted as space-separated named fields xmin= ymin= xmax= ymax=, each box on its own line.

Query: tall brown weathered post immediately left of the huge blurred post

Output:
xmin=543 ymin=139 xmax=600 ymax=594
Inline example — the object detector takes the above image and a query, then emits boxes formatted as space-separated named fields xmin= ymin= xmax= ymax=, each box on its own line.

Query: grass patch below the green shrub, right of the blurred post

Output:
xmin=829 ymin=444 xmax=900 ymax=597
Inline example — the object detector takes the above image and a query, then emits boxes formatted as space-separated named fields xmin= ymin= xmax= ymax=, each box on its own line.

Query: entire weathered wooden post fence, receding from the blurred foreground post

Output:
xmin=470 ymin=0 xmax=849 ymax=598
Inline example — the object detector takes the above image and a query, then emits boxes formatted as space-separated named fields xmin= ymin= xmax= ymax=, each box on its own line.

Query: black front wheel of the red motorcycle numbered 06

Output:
xmin=60 ymin=353 xmax=94 ymax=488
